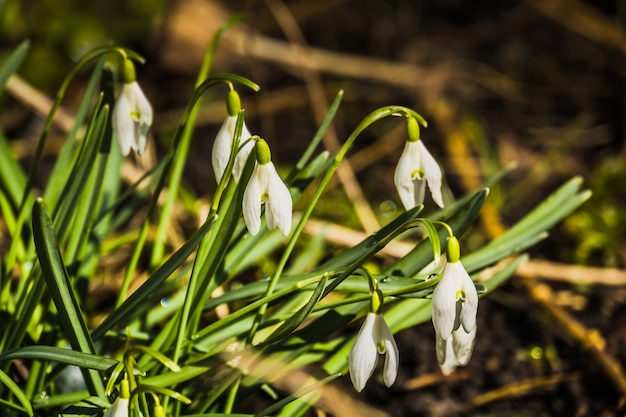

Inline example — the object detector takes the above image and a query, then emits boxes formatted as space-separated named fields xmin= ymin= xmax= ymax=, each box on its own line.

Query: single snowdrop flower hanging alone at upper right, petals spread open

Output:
xmin=394 ymin=117 xmax=443 ymax=210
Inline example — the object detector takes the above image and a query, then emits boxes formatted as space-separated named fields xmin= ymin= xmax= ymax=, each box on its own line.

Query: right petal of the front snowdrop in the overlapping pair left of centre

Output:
xmin=265 ymin=162 xmax=293 ymax=236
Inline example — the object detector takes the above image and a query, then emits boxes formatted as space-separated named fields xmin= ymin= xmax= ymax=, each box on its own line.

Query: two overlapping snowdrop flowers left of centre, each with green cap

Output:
xmin=211 ymin=90 xmax=293 ymax=236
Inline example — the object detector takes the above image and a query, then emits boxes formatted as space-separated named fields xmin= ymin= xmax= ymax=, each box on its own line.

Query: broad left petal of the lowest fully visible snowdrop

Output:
xmin=348 ymin=313 xmax=378 ymax=392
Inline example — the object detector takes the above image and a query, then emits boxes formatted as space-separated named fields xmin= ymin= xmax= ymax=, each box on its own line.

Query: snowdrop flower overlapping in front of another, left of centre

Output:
xmin=243 ymin=139 xmax=292 ymax=236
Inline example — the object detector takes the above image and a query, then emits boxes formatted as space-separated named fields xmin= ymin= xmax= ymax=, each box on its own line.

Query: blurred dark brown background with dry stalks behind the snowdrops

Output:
xmin=0 ymin=0 xmax=626 ymax=416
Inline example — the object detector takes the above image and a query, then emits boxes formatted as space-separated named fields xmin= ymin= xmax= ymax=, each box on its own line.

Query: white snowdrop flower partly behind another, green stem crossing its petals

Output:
xmin=211 ymin=90 xmax=254 ymax=184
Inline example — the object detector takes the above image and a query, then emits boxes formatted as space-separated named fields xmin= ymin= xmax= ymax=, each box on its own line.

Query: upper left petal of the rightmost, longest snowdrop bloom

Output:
xmin=432 ymin=263 xmax=461 ymax=339
